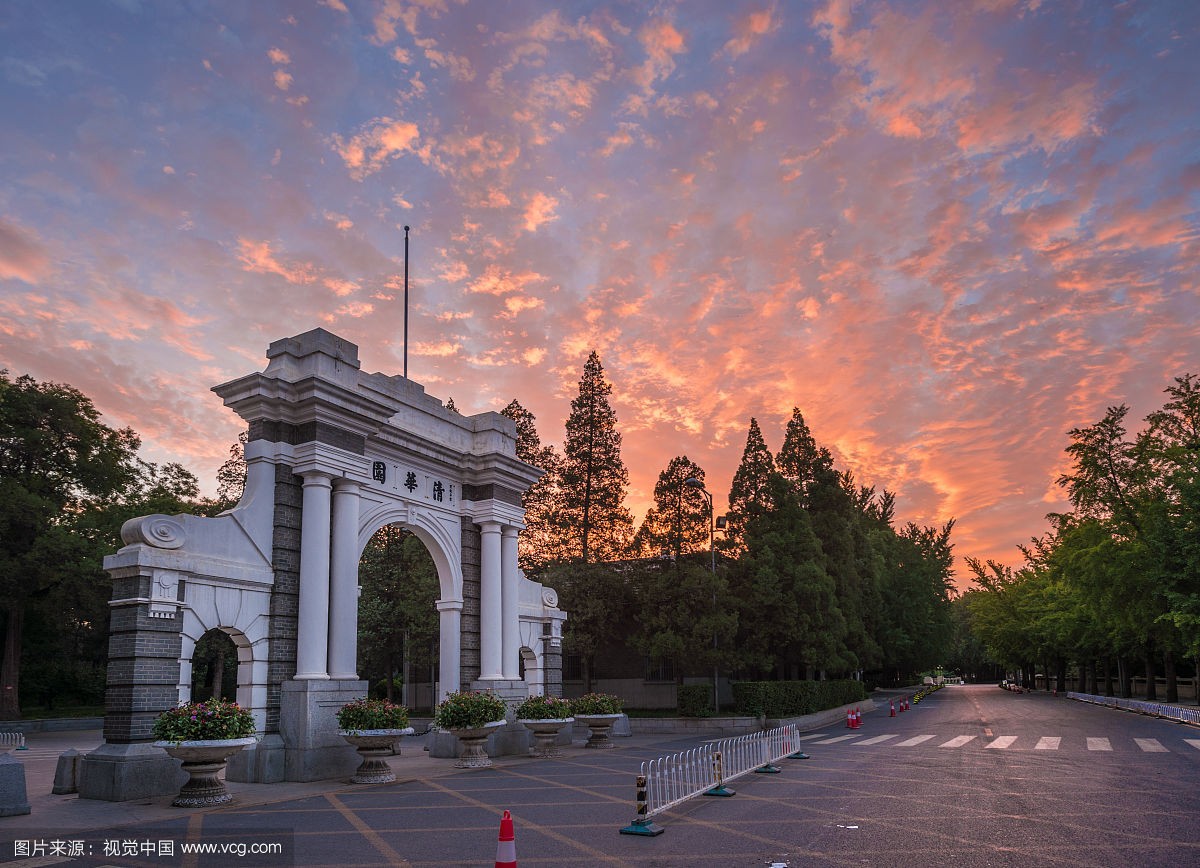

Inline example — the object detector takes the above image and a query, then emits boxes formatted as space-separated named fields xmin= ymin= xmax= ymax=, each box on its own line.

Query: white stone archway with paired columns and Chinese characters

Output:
xmin=80 ymin=329 xmax=565 ymax=800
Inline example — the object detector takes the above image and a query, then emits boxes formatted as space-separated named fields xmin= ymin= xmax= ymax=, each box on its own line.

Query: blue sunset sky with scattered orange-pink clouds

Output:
xmin=0 ymin=0 xmax=1200 ymax=588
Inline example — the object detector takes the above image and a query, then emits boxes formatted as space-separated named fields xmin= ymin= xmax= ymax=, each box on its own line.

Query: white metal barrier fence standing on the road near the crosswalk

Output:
xmin=620 ymin=724 xmax=809 ymax=836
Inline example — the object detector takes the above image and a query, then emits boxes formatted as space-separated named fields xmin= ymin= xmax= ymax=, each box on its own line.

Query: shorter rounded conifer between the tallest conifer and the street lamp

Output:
xmin=634 ymin=455 xmax=710 ymax=558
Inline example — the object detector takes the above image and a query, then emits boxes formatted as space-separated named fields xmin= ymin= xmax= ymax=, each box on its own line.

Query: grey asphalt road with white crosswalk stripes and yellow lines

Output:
xmin=7 ymin=686 xmax=1200 ymax=868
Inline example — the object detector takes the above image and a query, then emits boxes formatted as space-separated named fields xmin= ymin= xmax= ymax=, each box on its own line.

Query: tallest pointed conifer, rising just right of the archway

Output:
xmin=556 ymin=351 xmax=634 ymax=563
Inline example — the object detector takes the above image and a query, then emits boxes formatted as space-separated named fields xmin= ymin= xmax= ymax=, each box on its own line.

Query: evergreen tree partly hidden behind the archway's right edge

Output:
xmin=500 ymin=399 xmax=565 ymax=571
